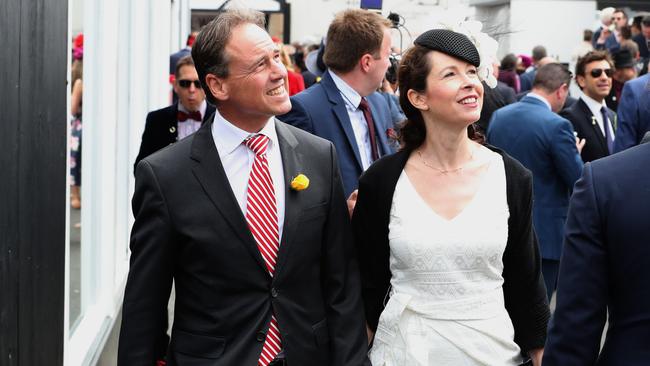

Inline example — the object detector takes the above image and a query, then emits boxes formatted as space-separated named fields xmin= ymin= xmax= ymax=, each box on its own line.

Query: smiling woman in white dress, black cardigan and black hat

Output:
xmin=353 ymin=29 xmax=549 ymax=366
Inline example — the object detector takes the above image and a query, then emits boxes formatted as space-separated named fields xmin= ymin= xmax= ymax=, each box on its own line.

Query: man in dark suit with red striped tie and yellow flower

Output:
xmin=118 ymin=10 xmax=367 ymax=366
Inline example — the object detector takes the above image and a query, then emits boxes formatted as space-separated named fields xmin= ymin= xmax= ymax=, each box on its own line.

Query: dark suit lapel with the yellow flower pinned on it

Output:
xmin=275 ymin=119 xmax=304 ymax=280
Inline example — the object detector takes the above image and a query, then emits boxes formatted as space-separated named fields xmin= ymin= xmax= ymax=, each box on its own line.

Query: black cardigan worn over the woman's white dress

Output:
xmin=352 ymin=146 xmax=550 ymax=352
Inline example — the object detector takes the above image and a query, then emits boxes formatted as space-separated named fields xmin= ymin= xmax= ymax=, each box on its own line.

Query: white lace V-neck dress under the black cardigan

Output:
xmin=370 ymin=154 xmax=522 ymax=366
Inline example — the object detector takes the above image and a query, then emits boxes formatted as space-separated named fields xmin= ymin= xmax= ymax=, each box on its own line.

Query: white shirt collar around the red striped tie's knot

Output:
xmin=212 ymin=109 xmax=279 ymax=156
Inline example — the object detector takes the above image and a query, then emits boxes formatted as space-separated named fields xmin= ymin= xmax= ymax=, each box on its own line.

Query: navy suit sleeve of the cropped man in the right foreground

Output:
xmin=543 ymin=164 xmax=608 ymax=366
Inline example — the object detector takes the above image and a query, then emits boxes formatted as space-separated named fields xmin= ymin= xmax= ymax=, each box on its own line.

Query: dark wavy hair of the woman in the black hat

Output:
xmin=397 ymin=45 xmax=484 ymax=151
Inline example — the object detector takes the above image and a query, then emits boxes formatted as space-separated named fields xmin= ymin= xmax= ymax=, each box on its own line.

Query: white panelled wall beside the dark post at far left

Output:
xmin=64 ymin=0 xmax=173 ymax=366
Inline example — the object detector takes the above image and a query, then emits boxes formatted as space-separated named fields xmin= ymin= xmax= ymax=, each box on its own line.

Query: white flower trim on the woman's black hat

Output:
xmin=436 ymin=20 xmax=499 ymax=89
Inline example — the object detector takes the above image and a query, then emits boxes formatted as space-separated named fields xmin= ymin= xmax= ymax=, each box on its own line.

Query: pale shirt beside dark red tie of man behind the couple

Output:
xmin=330 ymin=71 xmax=379 ymax=170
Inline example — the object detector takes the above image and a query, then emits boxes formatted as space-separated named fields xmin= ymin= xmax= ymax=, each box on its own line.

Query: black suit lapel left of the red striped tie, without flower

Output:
xmin=191 ymin=119 xmax=268 ymax=273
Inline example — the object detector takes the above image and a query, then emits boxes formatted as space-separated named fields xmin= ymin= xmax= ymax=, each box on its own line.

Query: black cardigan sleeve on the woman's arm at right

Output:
xmin=503 ymin=168 xmax=550 ymax=352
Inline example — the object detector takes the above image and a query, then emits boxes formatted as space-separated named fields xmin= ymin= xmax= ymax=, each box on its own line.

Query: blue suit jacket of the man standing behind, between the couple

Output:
xmin=278 ymin=71 xmax=397 ymax=197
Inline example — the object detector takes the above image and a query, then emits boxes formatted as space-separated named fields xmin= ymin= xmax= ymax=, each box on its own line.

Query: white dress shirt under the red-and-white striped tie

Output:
xmin=212 ymin=110 xmax=285 ymax=240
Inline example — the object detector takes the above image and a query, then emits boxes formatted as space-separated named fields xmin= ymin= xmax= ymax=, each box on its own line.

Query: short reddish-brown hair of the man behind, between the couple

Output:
xmin=323 ymin=9 xmax=391 ymax=73
